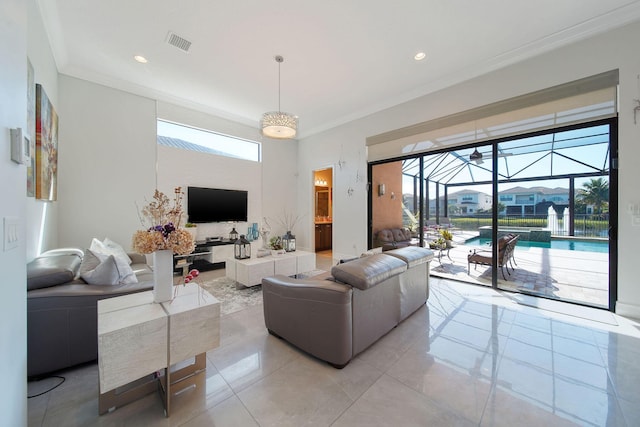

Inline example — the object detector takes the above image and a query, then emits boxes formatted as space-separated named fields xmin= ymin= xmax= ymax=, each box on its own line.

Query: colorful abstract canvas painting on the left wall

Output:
xmin=35 ymin=84 xmax=58 ymax=201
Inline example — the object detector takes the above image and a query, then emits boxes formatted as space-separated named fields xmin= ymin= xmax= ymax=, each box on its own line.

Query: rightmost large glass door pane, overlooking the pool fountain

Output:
xmin=497 ymin=123 xmax=615 ymax=308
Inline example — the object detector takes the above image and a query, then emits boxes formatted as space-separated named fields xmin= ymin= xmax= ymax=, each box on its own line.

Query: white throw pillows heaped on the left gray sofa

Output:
xmin=80 ymin=249 xmax=138 ymax=285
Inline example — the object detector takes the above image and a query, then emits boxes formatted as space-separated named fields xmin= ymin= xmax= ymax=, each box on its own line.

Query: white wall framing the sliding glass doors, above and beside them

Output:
xmin=298 ymin=20 xmax=640 ymax=317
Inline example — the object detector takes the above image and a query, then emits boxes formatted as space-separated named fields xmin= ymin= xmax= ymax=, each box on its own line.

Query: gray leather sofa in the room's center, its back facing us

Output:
xmin=262 ymin=246 xmax=433 ymax=368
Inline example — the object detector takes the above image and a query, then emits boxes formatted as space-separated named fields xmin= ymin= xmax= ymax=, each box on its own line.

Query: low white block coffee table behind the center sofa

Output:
xmin=225 ymin=251 xmax=316 ymax=287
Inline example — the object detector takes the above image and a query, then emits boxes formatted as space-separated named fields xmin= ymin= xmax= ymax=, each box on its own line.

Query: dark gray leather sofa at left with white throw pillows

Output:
xmin=27 ymin=245 xmax=153 ymax=378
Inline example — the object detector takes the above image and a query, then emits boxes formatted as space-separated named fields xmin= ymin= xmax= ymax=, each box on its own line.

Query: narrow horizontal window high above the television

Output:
xmin=157 ymin=120 xmax=261 ymax=162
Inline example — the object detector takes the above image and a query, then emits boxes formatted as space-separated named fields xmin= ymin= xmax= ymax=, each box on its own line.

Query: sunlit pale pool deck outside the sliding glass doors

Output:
xmin=431 ymin=231 xmax=609 ymax=308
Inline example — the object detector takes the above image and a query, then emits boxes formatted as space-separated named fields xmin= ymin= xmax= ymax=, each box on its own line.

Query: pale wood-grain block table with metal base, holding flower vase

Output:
xmin=98 ymin=283 xmax=220 ymax=416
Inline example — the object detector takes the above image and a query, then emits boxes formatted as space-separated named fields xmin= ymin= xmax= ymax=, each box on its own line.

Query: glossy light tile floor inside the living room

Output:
xmin=29 ymin=259 xmax=640 ymax=427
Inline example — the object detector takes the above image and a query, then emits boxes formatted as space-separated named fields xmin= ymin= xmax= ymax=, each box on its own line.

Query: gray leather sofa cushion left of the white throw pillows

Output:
xmin=27 ymin=255 xmax=81 ymax=291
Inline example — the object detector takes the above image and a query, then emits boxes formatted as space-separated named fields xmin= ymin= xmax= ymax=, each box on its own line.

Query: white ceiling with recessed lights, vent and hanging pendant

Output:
xmin=37 ymin=0 xmax=640 ymax=137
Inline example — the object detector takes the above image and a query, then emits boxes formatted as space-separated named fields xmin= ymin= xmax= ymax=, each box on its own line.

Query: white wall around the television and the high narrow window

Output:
xmin=158 ymin=102 xmax=304 ymax=244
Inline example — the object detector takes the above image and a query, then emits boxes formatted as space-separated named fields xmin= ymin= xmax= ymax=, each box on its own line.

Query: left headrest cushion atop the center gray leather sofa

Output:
xmin=331 ymin=254 xmax=407 ymax=290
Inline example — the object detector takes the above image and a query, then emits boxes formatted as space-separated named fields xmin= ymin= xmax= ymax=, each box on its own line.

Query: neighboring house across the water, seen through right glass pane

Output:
xmin=498 ymin=187 xmax=569 ymax=216
